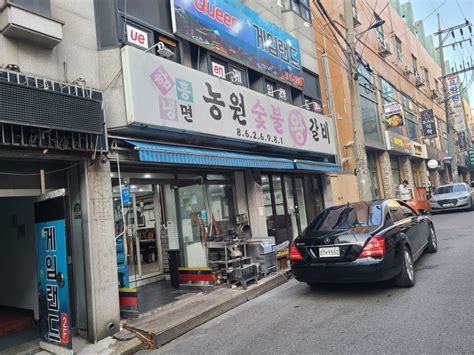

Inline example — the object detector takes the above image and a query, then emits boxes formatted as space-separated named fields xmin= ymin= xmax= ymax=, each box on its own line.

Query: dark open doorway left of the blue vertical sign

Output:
xmin=0 ymin=197 xmax=39 ymax=352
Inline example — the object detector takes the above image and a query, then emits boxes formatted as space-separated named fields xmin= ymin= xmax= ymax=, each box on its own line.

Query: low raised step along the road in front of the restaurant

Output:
xmin=79 ymin=272 xmax=289 ymax=354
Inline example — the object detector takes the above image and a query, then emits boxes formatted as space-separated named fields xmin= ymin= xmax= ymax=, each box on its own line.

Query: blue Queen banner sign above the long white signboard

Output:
xmin=171 ymin=0 xmax=304 ymax=88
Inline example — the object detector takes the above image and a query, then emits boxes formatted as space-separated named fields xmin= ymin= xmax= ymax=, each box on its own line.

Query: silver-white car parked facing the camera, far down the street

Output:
xmin=430 ymin=183 xmax=474 ymax=213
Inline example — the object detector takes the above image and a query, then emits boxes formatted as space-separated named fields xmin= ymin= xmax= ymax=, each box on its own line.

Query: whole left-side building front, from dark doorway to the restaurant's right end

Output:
xmin=0 ymin=0 xmax=339 ymax=351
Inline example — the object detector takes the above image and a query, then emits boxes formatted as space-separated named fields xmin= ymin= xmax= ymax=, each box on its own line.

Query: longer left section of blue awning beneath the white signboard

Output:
xmin=127 ymin=141 xmax=294 ymax=170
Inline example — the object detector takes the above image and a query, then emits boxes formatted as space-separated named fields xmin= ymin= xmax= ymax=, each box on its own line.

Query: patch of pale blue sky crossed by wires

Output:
xmin=408 ymin=0 xmax=474 ymax=108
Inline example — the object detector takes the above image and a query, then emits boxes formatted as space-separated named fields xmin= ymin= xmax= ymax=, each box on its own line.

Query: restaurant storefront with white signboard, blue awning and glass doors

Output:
xmin=105 ymin=46 xmax=339 ymax=308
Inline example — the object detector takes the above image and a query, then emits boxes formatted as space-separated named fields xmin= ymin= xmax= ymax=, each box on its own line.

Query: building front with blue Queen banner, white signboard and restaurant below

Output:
xmin=95 ymin=1 xmax=339 ymax=294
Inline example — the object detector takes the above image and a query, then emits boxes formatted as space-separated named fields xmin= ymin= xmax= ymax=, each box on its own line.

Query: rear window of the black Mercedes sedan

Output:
xmin=303 ymin=202 xmax=382 ymax=234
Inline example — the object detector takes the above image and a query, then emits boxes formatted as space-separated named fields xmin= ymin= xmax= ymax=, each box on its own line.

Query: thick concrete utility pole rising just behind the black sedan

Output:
xmin=344 ymin=0 xmax=372 ymax=201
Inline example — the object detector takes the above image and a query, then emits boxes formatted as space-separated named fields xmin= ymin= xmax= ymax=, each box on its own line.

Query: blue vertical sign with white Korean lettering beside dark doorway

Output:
xmin=35 ymin=189 xmax=72 ymax=353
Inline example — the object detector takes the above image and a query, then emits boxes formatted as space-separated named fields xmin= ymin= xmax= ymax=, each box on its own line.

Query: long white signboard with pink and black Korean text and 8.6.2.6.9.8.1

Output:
xmin=122 ymin=46 xmax=336 ymax=155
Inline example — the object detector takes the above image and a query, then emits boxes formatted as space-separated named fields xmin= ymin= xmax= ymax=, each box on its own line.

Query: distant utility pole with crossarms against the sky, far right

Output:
xmin=436 ymin=14 xmax=471 ymax=182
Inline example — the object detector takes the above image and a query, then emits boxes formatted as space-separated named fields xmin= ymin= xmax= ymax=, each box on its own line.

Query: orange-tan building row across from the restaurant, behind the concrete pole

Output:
xmin=314 ymin=0 xmax=468 ymax=200
